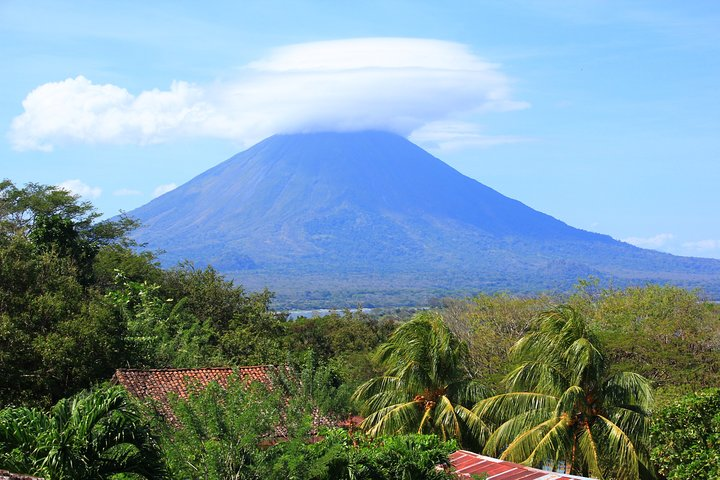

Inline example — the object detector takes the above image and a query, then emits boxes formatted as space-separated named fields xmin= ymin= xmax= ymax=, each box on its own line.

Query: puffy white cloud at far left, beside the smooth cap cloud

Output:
xmin=10 ymin=76 xmax=210 ymax=151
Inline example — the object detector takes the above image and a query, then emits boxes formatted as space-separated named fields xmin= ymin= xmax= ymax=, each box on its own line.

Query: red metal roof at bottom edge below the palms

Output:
xmin=450 ymin=450 xmax=588 ymax=480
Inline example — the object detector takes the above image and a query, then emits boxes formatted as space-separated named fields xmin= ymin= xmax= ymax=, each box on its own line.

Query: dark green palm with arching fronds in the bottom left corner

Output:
xmin=0 ymin=387 xmax=166 ymax=480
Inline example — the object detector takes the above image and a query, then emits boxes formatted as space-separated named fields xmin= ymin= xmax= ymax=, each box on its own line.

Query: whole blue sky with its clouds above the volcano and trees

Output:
xmin=0 ymin=0 xmax=720 ymax=258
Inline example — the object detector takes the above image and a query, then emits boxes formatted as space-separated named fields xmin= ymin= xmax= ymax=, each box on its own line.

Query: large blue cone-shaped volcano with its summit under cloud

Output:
xmin=130 ymin=131 xmax=720 ymax=308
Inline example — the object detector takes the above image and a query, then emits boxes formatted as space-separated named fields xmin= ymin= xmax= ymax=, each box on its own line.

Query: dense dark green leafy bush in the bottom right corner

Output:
xmin=651 ymin=388 xmax=720 ymax=480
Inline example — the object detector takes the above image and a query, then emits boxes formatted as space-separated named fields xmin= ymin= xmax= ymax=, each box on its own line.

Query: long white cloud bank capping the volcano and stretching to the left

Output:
xmin=10 ymin=38 xmax=528 ymax=150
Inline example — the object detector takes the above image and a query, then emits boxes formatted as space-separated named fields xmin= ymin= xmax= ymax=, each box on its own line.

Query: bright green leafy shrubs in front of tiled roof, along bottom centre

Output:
xmin=162 ymin=379 xmax=456 ymax=480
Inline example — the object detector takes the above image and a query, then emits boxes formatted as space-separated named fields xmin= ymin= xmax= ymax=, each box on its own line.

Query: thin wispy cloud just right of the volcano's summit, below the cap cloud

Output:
xmin=409 ymin=120 xmax=531 ymax=152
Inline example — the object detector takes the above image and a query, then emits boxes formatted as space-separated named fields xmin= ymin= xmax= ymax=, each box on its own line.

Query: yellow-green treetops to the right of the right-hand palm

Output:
xmin=570 ymin=282 xmax=720 ymax=400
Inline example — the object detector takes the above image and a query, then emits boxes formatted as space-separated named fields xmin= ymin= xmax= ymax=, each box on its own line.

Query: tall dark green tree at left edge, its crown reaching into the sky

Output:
xmin=0 ymin=180 xmax=148 ymax=406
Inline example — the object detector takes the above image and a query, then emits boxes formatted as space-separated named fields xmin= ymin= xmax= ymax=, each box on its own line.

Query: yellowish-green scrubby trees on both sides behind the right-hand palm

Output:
xmin=442 ymin=279 xmax=720 ymax=406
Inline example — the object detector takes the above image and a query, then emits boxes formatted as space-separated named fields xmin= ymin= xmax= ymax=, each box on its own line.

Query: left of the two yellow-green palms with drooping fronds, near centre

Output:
xmin=354 ymin=312 xmax=490 ymax=444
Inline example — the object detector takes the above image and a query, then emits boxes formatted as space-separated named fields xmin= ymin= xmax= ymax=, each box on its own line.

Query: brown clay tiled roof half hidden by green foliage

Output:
xmin=112 ymin=365 xmax=278 ymax=421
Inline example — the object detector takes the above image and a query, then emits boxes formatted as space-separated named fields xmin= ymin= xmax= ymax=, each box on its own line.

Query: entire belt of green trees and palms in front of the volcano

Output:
xmin=0 ymin=181 xmax=720 ymax=480
